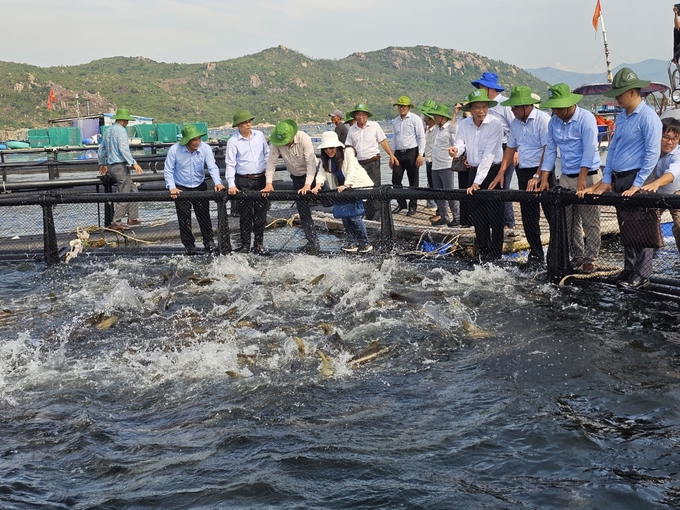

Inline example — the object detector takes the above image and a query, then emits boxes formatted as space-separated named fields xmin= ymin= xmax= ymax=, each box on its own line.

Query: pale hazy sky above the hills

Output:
xmin=0 ymin=0 xmax=674 ymax=73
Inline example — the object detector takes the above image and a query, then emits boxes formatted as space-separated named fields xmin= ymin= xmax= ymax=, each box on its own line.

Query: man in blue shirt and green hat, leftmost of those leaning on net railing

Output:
xmin=163 ymin=124 xmax=224 ymax=255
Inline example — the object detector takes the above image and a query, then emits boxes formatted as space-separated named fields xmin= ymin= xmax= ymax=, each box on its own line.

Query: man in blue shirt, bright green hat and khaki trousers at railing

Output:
xmin=539 ymin=83 xmax=601 ymax=274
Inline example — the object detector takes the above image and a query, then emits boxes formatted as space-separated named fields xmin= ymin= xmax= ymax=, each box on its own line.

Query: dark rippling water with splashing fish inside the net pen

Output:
xmin=0 ymin=254 xmax=680 ymax=509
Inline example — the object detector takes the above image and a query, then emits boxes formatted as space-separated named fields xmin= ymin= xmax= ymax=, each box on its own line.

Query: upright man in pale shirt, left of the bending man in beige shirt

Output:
xmin=224 ymin=110 xmax=269 ymax=254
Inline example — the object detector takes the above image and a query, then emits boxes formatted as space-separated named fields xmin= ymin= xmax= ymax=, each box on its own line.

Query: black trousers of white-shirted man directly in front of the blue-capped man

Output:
xmin=468 ymin=163 xmax=505 ymax=262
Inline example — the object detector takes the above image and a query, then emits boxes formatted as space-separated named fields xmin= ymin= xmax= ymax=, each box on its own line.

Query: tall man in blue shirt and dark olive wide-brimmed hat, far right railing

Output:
xmin=579 ymin=67 xmax=662 ymax=289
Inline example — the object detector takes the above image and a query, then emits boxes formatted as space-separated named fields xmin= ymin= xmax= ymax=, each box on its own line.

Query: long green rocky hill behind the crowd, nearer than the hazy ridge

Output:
xmin=0 ymin=46 xmax=548 ymax=129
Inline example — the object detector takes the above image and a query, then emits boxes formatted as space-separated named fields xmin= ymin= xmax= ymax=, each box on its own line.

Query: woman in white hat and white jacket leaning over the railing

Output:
xmin=312 ymin=131 xmax=373 ymax=253
